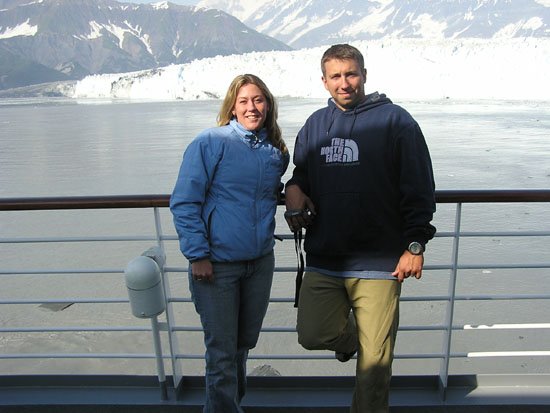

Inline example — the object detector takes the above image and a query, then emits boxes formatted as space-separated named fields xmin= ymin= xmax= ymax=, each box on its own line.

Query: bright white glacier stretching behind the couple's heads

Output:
xmin=74 ymin=38 xmax=550 ymax=100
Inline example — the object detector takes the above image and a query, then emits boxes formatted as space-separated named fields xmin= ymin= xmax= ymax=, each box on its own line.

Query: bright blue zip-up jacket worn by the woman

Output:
xmin=170 ymin=120 xmax=289 ymax=262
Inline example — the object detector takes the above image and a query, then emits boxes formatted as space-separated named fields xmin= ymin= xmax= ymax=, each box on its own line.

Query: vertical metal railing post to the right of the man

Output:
xmin=439 ymin=202 xmax=462 ymax=400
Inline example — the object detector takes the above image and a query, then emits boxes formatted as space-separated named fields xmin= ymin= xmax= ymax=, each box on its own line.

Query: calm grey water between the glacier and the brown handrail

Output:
xmin=0 ymin=96 xmax=550 ymax=197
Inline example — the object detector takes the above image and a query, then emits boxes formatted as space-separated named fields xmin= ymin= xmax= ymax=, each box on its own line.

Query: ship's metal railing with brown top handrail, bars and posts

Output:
xmin=0 ymin=190 xmax=550 ymax=397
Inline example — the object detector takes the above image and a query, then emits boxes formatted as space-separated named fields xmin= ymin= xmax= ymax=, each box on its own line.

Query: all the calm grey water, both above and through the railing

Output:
xmin=0 ymin=100 xmax=550 ymax=374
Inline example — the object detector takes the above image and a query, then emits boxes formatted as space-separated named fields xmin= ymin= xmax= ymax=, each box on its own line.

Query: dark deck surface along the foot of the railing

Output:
xmin=0 ymin=375 xmax=550 ymax=413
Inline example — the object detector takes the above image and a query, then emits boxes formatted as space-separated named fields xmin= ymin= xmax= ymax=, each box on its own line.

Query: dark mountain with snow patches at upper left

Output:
xmin=0 ymin=0 xmax=290 ymax=89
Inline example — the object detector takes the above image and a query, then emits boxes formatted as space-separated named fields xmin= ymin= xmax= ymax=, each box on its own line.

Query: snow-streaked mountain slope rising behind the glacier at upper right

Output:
xmin=198 ymin=0 xmax=550 ymax=48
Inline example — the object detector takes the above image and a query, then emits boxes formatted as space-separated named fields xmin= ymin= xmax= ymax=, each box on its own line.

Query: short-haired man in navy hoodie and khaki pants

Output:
xmin=285 ymin=45 xmax=435 ymax=412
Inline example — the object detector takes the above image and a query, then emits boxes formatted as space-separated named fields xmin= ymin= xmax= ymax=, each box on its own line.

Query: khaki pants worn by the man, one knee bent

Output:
xmin=297 ymin=271 xmax=401 ymax=413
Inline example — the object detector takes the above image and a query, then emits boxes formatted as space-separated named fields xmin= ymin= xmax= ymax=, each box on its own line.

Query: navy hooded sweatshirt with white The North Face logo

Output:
xmin=287 ymin=93 xmax=435 ymax=272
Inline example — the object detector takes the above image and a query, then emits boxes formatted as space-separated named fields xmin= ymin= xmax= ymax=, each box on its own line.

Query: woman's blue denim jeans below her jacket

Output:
xmin=189 ymin=252 xmax=275 ymax=413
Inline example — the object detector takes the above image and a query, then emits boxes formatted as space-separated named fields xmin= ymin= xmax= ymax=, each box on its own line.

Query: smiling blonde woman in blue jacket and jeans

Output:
xmin=170 ymin=74 xmax=289 ymax=413
